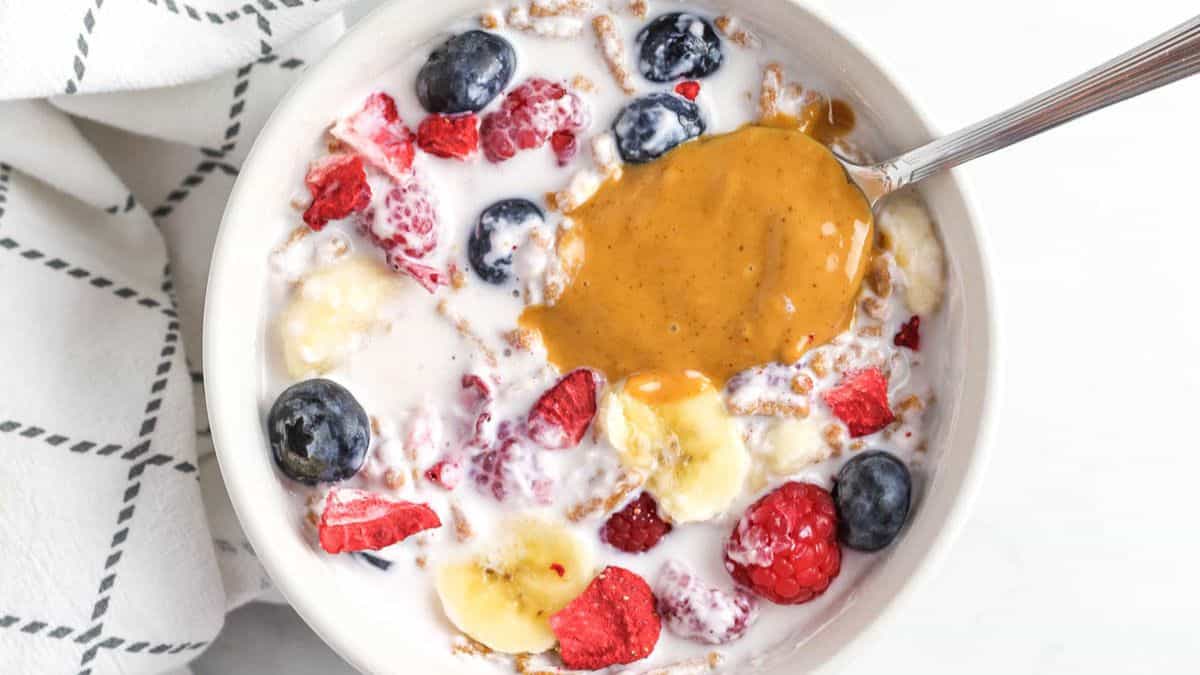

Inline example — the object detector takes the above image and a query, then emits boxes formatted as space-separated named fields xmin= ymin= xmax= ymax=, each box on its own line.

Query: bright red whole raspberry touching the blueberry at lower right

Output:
xmin=725 ymin=482 xmax=841 ymax=604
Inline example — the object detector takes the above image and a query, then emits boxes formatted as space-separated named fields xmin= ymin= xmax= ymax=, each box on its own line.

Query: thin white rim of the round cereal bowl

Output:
xmin=203 ymin=0 xmax=1001 ymax=673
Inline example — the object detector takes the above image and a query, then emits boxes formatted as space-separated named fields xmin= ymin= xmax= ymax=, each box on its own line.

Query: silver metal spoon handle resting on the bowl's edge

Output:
xmin=838 ymin=17 xmax=1200 ymax=208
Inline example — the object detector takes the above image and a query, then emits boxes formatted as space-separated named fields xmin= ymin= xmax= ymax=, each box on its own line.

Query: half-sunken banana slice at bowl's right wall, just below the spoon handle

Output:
xmin=878 ymin=195 xmax=946 ymax=315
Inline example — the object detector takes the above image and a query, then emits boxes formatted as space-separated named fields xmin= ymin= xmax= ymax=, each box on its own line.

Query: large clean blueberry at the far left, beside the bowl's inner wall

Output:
xmin=266 ymin=380 xmax=371 ymax=485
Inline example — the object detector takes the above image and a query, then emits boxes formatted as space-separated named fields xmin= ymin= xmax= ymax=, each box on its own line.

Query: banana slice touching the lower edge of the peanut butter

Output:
xmin=600 ymin=374 xmax=750 ymax=522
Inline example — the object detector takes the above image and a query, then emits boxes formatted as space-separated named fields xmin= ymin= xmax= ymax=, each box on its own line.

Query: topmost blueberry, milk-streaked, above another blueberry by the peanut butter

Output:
xmin=637 ymin=12 xmax=724 ymax=82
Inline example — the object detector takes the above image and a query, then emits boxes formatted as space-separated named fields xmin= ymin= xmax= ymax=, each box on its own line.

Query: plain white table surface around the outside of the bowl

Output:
xmin=196 ymin=0 xmax=1200 ymax=675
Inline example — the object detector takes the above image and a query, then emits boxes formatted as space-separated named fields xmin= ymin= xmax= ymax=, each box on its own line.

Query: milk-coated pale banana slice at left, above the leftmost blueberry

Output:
xmin=280 ymin=257 xmax=398 ymax=378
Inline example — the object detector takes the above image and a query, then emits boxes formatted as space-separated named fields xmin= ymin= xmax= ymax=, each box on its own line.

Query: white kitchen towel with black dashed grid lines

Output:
xmin=0 ymin=0 xmax=355 ymax=675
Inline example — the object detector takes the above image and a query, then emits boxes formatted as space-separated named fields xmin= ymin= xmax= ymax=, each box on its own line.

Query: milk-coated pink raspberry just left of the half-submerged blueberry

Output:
xmin=359 ymin=177 xmax=438 ymax=258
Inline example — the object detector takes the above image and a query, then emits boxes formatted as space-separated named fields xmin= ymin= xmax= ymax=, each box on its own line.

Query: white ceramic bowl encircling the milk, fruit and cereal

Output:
xmin=204 ymin=0 xmax=996 ymax=673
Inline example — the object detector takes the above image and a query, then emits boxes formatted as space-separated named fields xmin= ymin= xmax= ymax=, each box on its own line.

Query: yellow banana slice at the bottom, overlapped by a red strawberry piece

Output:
xmin=436 ymin=516 xmax=595 ymax=653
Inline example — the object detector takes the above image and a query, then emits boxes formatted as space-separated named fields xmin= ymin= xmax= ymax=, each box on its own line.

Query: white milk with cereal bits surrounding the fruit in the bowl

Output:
xmin=260 ymin=0 xmax=944 ymax=674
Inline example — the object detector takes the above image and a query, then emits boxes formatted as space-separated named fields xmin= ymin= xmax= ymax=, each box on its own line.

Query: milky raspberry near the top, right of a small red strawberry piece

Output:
xmin=480 ymin=77 xmax=588 ymax=162
